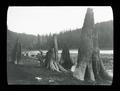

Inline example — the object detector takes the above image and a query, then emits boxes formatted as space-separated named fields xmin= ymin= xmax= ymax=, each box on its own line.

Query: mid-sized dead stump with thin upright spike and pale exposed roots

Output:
xmin=45 ymin=35 xmax=67 ymax=72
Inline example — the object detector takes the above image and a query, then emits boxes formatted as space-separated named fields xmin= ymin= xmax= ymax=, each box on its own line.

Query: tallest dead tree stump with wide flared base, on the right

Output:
xmin=73 ymin=8 xmax=112 ymax=81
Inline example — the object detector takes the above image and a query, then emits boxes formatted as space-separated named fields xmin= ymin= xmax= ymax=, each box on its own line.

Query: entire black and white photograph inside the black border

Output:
xmin=7 ymin=6 xmax=114 ymax=86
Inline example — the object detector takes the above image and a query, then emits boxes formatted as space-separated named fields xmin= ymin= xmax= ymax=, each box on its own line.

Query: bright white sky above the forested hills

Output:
xmin=7 ymin=6 xmax=113 ymax=35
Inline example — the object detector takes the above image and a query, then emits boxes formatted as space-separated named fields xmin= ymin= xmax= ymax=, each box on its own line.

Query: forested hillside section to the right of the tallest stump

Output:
xmin=95 ymin=21 xmax=113 ymax=49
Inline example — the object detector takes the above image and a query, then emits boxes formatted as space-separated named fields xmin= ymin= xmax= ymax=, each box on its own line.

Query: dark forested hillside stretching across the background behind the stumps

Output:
xmin=7 ymin=21 xmax=113 ymax=55
